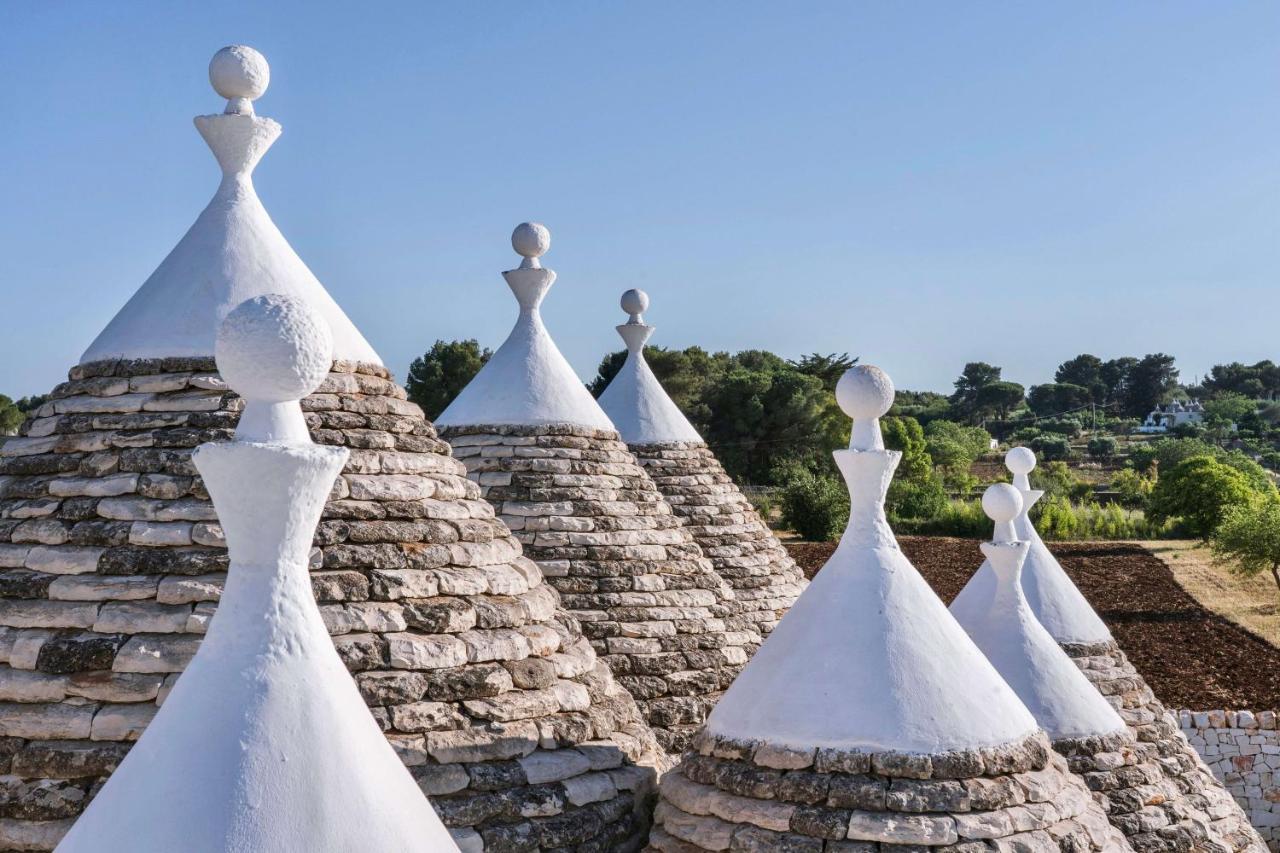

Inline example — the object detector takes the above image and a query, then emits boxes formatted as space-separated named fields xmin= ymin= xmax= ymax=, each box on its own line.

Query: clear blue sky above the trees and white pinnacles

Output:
xmin=0 ymin=0 xmax=1280 ymax=397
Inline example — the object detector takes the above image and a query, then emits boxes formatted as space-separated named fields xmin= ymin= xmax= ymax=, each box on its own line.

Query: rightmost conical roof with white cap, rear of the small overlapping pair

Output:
xmin=951 ymin=447 xmax=1265 ymax=852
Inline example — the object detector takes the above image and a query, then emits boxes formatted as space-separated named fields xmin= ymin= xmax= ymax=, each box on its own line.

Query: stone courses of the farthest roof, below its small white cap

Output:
xmin=628 ymin=442 xmax=808 ymax=637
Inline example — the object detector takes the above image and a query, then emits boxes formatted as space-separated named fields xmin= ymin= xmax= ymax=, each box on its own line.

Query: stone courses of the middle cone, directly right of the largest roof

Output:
xmin=444 ymin=424 xmax=759 ymax=753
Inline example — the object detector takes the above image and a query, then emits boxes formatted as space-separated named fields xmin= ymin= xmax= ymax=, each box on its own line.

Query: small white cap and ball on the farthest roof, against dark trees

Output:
xmin=600 ymin=289 xmax=703 ymax=446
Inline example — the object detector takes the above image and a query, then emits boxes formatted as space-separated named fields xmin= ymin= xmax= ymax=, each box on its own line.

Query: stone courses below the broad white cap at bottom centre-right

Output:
xmin=649 ymin=734 xmax=1129 ymax=853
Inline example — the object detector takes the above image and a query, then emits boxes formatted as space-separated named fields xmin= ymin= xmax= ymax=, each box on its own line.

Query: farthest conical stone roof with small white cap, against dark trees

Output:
xmin=600 ymin=289 xmax=808 ymax=637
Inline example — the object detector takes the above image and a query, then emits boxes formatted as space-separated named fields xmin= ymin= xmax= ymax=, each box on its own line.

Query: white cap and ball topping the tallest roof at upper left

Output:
xmin=81 ymin=45 xmax=381 ymax=364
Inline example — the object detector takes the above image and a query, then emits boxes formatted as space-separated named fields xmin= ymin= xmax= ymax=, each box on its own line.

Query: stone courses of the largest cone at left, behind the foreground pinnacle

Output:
xmin=0 ymin=48 xmax=658 ymax=850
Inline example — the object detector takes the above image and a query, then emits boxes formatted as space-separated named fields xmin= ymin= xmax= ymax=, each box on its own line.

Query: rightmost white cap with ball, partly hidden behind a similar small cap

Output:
xmin=951 ymin=447 xmax=1112 ymax=644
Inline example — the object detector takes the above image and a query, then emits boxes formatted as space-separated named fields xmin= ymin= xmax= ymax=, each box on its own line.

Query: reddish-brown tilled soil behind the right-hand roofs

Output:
xmin=787 ymin=537 xmax=1280 ymax=711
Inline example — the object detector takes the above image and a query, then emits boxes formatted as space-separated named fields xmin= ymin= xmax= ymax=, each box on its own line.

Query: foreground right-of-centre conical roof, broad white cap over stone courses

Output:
xmin=650 ymin=365 xmax=1129 ymax=853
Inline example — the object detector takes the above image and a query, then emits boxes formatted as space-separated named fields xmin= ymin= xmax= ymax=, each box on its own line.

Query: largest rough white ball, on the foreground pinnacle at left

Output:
xmin=214 ymin=293 xmax=333 ymax=402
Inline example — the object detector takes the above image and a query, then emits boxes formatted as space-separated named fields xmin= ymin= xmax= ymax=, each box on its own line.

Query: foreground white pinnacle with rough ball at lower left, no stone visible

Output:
xmin=58 ymin=296 xmax=457 ymax=853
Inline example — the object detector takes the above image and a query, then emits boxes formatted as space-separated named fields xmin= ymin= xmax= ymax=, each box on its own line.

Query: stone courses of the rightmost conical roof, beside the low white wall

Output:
xmin=1062 ymin=642 xmax=1266 ymax=853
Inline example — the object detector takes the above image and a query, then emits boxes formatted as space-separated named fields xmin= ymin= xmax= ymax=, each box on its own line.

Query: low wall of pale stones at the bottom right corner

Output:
xmin=1178 ymin=711 xmax=1280 ymax=850
